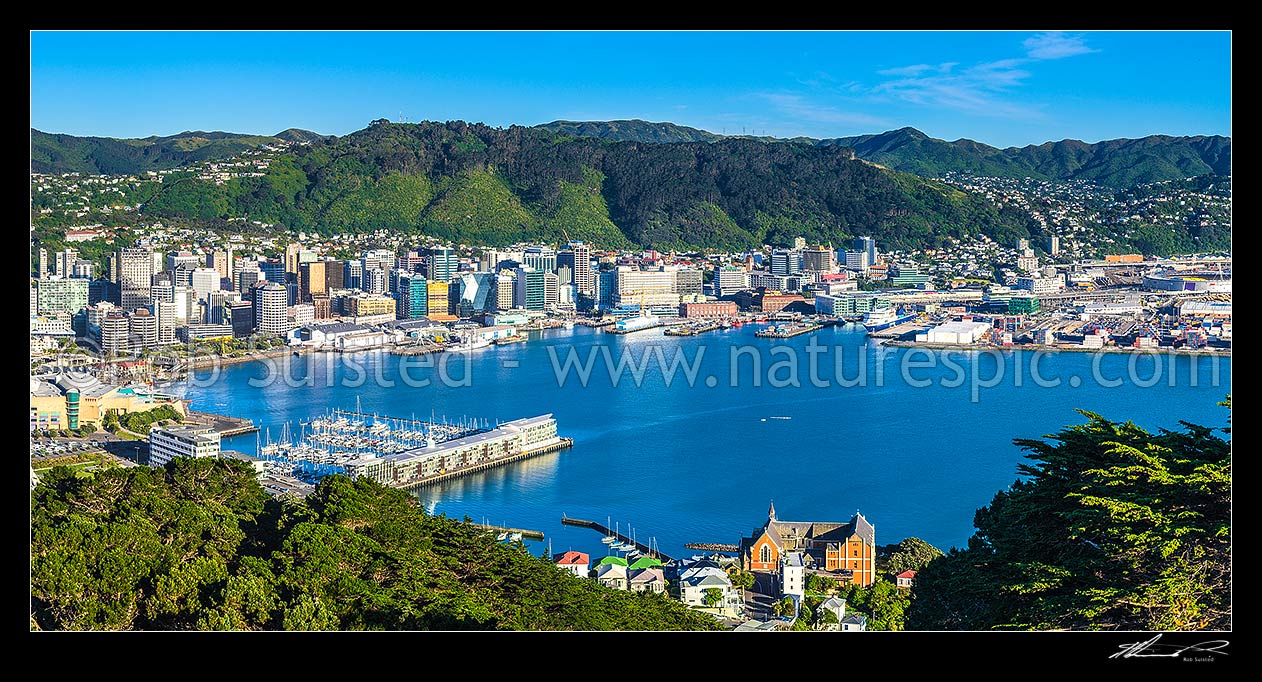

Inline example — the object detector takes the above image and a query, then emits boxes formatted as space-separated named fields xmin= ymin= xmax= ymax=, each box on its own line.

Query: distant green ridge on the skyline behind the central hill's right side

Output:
xmin=539 ymin=120 xmax=1232 ymax=187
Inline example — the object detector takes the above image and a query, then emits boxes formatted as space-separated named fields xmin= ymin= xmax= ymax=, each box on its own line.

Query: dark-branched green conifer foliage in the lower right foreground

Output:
xmin=907 ymin=400 xmax=1232 ymax=630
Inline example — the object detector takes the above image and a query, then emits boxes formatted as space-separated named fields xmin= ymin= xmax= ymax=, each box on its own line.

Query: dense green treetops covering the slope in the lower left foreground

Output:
xmin=30 ymin=457 xmax=718 ymax=630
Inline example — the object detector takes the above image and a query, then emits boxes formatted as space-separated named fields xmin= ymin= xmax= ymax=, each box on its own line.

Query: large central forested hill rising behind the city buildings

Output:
xmin=143 ymin=121 xmax=1034 ymax=250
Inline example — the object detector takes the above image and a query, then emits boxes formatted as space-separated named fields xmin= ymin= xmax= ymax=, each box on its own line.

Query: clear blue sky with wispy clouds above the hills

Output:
xmin=30 ymin=32 xmax=1232 ymax=147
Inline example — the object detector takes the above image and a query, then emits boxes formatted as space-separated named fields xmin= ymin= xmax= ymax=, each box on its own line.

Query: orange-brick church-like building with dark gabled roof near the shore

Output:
xmin=741 ymin=504 xmax=876 ymax=586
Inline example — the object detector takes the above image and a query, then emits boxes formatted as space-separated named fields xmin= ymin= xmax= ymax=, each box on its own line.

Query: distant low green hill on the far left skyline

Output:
xmin=30 ymin=128 xmax=324 ymax=174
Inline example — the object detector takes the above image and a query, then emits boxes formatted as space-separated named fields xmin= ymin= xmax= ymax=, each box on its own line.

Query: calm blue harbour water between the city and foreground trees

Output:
xmin=186 ymin=325 xmax=1230 ymax=556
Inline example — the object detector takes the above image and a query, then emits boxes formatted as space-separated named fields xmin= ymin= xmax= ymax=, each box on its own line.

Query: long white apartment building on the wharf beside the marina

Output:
xmin=346 ymin=414 xmax=562 ymax=488
